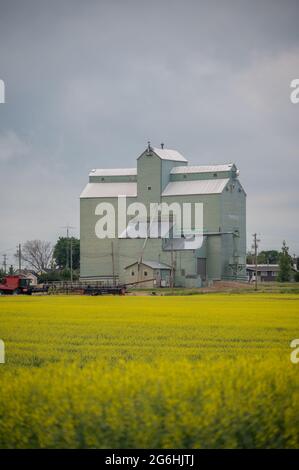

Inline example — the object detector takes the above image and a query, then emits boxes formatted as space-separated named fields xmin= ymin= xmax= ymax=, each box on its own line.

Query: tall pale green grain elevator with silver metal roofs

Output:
xmin=80 ymin=145 xmax=246 ymax=287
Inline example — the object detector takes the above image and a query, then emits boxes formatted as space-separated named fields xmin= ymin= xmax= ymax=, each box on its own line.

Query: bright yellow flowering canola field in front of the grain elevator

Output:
xmin=0 ymin=293 xmax=299 ymax=448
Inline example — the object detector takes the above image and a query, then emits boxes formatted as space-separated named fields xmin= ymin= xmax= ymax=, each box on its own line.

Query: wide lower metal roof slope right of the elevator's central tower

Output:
xmin=162 ymin=178 xmax=229 ymax=196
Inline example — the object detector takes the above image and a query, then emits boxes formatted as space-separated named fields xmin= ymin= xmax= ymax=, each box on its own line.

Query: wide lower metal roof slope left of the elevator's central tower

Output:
xmin=80 ymin=183 xmax=137 ymax=199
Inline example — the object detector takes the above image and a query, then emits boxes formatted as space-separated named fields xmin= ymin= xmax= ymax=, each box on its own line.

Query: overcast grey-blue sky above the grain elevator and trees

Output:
xmin=0 ymin=0 xmax=299 ymax=261
